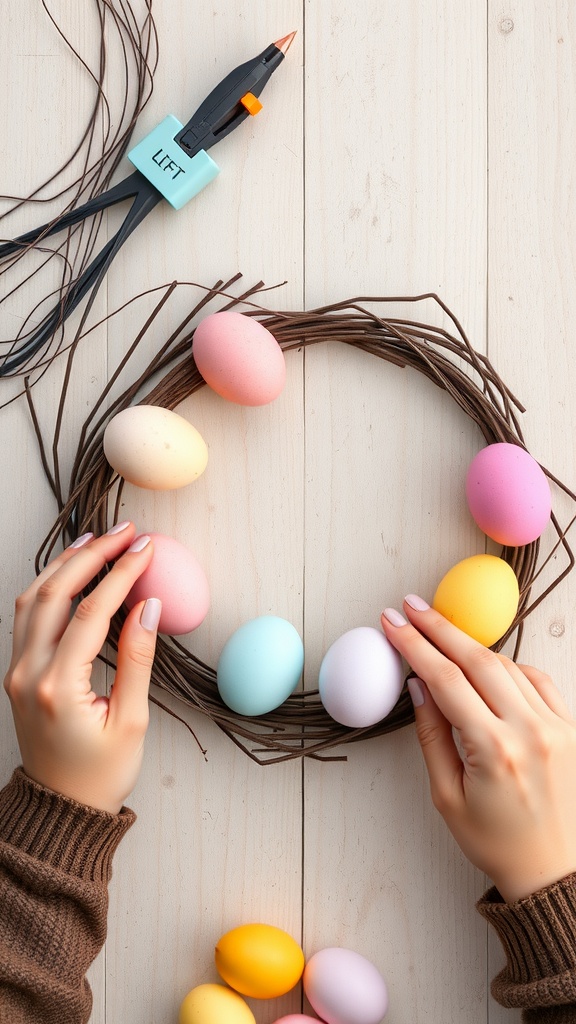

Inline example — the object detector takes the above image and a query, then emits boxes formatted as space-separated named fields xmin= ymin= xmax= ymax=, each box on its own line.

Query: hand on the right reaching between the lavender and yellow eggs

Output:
xmin=382 ymin=595 xmax=576 ymax=902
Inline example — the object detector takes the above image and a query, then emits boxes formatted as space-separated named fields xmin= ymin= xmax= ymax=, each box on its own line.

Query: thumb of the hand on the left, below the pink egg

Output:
xmin=109 ymin=597 xmax=162 ymax=735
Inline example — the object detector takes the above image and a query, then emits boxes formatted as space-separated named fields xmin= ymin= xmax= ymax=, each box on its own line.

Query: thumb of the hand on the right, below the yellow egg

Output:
xmin=408 ymin=677 xmax=462 ymax=813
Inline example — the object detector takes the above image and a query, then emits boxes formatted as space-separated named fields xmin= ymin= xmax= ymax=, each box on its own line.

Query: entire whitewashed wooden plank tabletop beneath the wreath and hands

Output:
xmin=0 ymin=0 xmax=576 ymax=1024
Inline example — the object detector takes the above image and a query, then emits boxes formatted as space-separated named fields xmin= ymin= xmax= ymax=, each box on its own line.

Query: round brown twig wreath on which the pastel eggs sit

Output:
xmin=28 ymin=278 xmax=576 ymax=764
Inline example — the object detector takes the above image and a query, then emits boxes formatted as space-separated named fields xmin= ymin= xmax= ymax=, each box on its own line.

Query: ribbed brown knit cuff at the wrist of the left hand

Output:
xmin=0 ymin=768 xmax=136 ymax=883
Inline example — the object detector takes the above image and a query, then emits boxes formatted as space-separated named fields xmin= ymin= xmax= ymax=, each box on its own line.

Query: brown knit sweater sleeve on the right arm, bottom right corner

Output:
xmin=478 ymin=874 xmax=576 ymax=1024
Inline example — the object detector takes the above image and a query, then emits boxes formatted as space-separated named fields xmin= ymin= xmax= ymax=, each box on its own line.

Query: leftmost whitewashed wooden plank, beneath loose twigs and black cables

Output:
xmin=0 ymin=2 xmax=113 ymax=1021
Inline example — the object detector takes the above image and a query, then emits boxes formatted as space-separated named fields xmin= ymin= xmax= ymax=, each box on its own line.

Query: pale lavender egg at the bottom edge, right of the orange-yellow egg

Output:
xmin=303 ymin=946 xmax=388 ymax=1024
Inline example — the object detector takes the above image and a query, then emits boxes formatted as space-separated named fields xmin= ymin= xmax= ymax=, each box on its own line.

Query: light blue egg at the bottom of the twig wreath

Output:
xmin=216 ymin=615 xmax=304 ymax=716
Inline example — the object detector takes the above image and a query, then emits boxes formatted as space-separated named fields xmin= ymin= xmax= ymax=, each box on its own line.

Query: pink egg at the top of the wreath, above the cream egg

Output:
xmin=192 ymin=310 xmax=286 ymax=406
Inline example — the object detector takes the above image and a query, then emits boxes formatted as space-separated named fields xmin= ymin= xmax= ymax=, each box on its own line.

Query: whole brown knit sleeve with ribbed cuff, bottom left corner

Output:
xmin=0 ymin=769 xmax=135 ymax=1024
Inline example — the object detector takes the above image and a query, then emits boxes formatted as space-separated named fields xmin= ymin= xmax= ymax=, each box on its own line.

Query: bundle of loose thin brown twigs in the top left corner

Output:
xmin=0 ymin=0 xmax=158 ymax=409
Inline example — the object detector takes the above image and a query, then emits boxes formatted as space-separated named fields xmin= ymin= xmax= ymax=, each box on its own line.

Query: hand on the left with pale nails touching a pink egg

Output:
xmin=4 ymin=523 xmax=160 ymax=814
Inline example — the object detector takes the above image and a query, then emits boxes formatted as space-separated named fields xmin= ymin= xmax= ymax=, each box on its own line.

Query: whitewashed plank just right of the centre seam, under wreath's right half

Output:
xmin=304 ymin=2 xmax=487 ymax=1022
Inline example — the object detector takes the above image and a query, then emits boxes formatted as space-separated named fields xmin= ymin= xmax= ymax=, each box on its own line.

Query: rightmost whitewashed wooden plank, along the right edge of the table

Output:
xmin=488 ymin=2 xmax=576 ymax=1024
